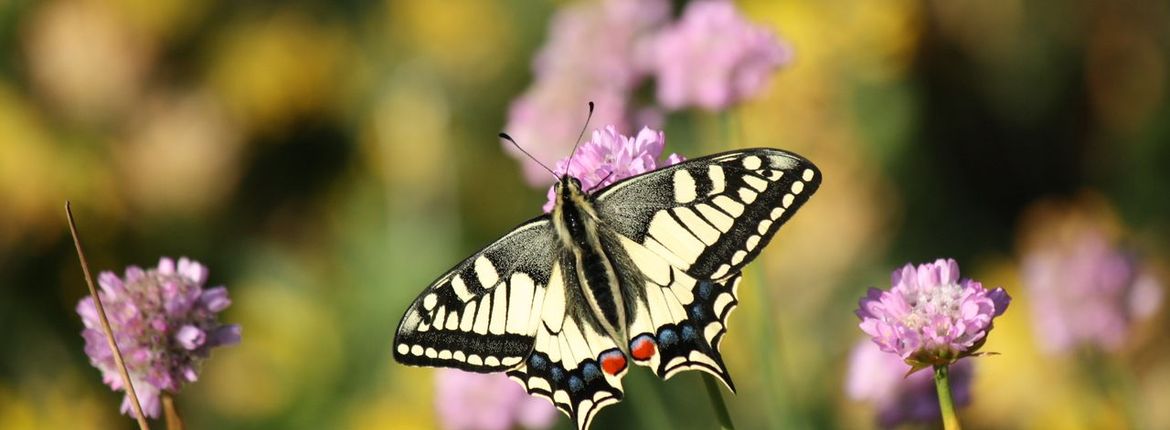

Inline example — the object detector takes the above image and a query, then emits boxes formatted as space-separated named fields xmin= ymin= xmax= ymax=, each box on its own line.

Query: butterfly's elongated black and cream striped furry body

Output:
xmin=552 ymin=175 xmax=627 ymax=346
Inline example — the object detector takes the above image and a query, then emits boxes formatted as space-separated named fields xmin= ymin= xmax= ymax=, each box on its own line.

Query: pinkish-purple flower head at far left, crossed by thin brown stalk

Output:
xmin=77 ymin=257 xmax=240 ymax=417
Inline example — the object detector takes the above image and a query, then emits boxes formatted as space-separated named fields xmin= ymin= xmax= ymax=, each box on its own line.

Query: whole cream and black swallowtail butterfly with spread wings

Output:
xmin=393 ymin=148 xmax=820 ymax=429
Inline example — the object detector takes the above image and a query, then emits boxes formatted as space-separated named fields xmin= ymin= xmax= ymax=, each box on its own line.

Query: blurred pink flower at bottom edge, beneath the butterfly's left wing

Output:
xmin=435 ymin=368 xmax=557 ymax=430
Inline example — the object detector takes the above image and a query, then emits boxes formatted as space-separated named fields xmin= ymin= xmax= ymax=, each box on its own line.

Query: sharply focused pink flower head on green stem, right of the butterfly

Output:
xmin=856 ymin=259 xmax=1011 ymax=368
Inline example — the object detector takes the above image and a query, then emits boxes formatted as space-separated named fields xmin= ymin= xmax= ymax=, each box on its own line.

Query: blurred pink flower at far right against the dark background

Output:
xmin=1021 ymin=226 xmax=1162 ymax=353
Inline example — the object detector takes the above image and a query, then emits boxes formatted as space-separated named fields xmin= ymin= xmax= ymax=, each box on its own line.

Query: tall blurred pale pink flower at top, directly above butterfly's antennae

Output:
xmin=504 ymin=0 xmax=669 ymax=186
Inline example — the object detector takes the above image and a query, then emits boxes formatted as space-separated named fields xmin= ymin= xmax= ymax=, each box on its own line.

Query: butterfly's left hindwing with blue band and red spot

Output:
xmin=508 ymin=257 xmax=627 ymax=429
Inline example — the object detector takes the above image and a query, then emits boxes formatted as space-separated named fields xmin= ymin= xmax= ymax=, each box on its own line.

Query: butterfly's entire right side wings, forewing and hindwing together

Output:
xmin=594 ymin=148 xmax=820 ymax=390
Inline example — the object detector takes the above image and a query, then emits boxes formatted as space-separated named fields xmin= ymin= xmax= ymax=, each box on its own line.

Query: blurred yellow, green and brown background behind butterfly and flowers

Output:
xmin=0 ymin=0 xmax=1170 ymax=429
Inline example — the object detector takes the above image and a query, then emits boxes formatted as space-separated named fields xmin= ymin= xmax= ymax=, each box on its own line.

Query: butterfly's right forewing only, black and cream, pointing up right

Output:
xmin=593 ymin=148 xmax=820 ymax=279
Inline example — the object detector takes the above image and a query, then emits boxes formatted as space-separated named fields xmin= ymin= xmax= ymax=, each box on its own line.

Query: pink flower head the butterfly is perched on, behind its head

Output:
xmin=544 ymin=125 xmax=684 ymax=211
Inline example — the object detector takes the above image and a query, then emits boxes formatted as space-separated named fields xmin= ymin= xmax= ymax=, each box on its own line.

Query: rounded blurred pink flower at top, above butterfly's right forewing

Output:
xmin=648 ymin=0 xmax=792 ymax=111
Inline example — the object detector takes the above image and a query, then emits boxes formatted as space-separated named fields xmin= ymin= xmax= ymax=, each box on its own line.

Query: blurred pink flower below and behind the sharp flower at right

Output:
xmin=845 ymin=340 xmax=975 ymax=429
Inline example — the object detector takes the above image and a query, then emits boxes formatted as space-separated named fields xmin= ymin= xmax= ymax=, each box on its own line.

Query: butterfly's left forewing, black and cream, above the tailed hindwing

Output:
xmin=394 ymin=215 xmax=558 ymax=373
